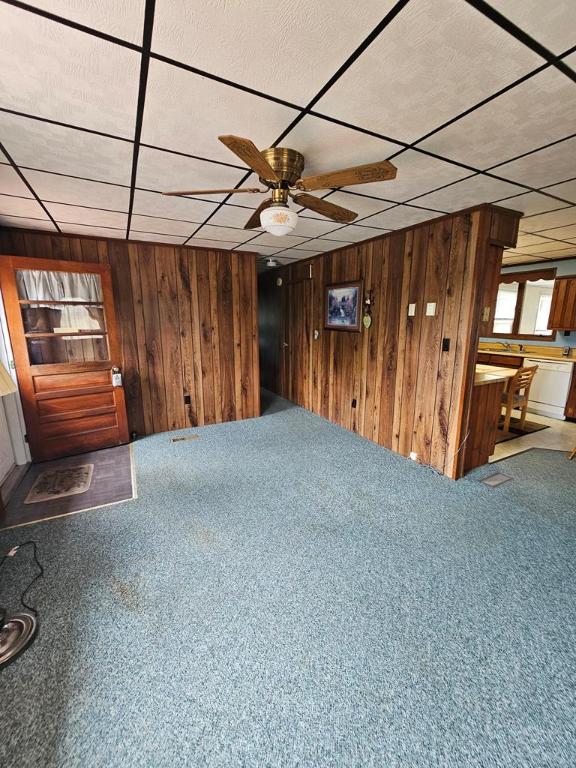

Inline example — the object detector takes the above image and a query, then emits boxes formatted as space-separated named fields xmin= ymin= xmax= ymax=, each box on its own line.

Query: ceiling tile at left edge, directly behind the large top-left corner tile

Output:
xmin=0 ymin=111 xmax=132 ymax=184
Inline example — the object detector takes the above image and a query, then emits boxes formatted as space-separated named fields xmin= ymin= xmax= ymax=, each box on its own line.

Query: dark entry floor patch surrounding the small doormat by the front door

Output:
xmin=0 ymin=445 xmax=136 ymax=528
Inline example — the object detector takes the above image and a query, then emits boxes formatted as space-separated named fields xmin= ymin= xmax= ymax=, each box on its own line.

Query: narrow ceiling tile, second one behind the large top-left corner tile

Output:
xmin=23 ymin=170 xmax=130 ymax=211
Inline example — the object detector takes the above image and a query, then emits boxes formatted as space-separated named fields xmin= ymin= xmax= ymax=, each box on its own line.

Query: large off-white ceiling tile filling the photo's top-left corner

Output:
xmin=0 ymin=3 xmax=140 ymax=138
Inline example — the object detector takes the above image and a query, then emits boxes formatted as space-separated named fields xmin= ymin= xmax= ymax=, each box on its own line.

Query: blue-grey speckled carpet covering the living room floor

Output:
xmin=0 ymin=392 xmax=576 ymax=768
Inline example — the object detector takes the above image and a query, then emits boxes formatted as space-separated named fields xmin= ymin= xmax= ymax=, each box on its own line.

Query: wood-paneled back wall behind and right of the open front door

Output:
xmin=0 ymin=229 xmax=260 ymax=434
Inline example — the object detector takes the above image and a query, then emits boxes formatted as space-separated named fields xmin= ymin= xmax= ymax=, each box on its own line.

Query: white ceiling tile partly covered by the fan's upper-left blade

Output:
xmin=140 ymin=60 xmax=297 ymax=162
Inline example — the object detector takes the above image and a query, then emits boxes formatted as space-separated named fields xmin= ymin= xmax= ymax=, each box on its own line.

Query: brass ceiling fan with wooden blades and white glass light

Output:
xmin=164 ymin=136 xmax=396 ymax=236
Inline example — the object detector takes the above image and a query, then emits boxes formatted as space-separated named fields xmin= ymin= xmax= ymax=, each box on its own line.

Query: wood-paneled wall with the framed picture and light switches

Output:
xmin=260 ymin=206 xmax=520 ymax=477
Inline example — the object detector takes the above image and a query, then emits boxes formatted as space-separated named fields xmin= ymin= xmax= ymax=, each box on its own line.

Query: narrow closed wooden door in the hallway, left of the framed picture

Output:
xmin=282 ymin=279 xmax=312 ymax=408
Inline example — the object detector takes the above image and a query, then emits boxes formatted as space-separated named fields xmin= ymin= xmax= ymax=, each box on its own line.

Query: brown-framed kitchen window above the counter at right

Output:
xmin=493 ymin=269 xmax=556 ymax=339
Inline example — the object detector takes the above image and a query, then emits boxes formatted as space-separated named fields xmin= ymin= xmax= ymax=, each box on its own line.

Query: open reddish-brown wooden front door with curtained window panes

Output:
xmin=0 ymin=256 xmax=128 ymax=461
